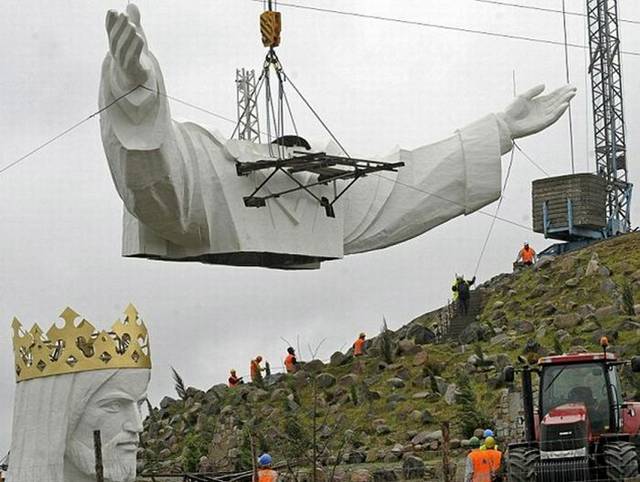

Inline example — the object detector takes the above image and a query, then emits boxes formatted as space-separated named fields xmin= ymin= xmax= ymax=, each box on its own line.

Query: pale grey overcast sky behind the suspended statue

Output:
xmin=0 ymin=0 xmax=640 ymax=455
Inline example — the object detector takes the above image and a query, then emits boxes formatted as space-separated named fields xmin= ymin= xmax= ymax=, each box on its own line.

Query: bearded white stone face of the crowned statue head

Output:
xmin=65 ymin=369 xmax=150 ymax=482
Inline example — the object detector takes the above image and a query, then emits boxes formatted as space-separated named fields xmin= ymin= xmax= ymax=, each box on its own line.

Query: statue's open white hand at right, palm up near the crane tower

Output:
xmin=498 ymin=84 xmax=576 ymax=139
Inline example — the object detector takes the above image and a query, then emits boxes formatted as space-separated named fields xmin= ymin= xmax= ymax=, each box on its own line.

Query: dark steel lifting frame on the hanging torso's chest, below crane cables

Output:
xmin=236 ymin=151 xmax=404 ymax=218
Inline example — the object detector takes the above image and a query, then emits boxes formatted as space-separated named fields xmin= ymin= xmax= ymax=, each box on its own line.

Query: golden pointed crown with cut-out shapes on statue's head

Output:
xmin=11 ymin=305 xmax=151 ymax=382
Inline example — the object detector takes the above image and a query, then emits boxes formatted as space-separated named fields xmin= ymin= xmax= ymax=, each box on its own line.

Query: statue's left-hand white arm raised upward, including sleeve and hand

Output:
xmin=100 ymin=4 xmax=207 ymax=246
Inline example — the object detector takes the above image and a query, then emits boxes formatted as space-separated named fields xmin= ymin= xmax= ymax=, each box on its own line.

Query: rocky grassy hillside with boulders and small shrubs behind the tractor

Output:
xmin=140 ymin=234 xmax=640 ymax=481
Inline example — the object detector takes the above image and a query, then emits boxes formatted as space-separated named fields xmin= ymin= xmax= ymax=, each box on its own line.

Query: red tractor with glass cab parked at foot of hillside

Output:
xmin=505 ymin=338 xmax=640 ymax=482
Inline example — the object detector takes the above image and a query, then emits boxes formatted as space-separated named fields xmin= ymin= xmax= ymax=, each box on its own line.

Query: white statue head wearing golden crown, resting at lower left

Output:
xmin=8 ymin=307 xmax=151 ymax=482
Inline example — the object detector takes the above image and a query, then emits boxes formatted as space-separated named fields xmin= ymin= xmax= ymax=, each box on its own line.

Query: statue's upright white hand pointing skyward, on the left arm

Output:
xmin=106 ymin=4 xmax=151 ymax=84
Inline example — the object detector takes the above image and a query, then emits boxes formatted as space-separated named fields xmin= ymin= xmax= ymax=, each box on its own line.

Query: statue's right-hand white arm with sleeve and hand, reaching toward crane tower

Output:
xmin=344 ymin=85 xmax=575 ymax=254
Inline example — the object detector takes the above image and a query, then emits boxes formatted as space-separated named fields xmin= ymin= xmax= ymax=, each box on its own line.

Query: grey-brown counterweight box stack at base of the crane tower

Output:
xmin=531 ymin=173 xmax=607 ymax=240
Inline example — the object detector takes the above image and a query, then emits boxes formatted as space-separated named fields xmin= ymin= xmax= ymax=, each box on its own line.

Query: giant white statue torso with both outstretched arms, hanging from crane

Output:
xmin=100 ymin=5 xmax=575 ymax=269
